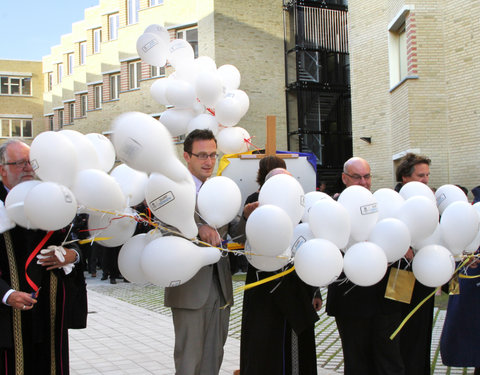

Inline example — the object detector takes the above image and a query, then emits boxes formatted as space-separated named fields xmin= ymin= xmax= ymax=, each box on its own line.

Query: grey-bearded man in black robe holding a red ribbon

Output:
xmin=0 ymin=140 xmax=87 ymax=375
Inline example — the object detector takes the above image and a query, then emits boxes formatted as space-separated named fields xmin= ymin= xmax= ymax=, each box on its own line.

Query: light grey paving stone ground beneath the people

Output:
xmin=70 ymin=276 xmax=473 ymax=375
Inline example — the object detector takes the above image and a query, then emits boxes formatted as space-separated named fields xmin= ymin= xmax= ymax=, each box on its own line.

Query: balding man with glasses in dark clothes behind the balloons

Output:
xmin=326 ymin=157 xmax=408 ymax=375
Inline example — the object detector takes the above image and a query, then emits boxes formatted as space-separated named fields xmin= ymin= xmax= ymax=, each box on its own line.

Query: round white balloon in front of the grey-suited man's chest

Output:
xmin=197 ymin=176 xmax=242 ymax=228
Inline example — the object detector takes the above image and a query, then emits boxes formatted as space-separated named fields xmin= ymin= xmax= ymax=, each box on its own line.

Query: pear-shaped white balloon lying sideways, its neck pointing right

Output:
xmin=140 ymin=236 xmax=220 ymax=287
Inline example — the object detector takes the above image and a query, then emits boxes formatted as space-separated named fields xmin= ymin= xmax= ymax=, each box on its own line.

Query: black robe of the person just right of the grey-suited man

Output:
xmin=240 ymin=194 xmax=319 ymax=375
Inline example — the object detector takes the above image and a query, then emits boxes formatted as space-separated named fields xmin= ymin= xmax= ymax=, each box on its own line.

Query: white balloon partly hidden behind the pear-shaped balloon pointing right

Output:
xmin=118 ymin=233 xmax=150 ymax=283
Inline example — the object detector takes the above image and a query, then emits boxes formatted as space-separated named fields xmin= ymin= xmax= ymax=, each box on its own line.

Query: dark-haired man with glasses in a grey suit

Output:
xmin=165 ymin=130 xmax=245 ymax=375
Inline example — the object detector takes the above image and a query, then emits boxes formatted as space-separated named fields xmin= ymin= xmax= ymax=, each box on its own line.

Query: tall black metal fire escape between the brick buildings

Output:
xmin=284 ymin=0 xmax=352 ymax=189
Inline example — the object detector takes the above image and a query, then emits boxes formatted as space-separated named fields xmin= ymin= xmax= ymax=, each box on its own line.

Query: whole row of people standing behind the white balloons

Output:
xmin=0 ymin=130 xmax=480 ymax=375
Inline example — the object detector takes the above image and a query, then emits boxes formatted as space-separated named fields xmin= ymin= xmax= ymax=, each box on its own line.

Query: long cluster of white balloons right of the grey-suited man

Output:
xmin=246 ymin=175 xmax=474 ymax=287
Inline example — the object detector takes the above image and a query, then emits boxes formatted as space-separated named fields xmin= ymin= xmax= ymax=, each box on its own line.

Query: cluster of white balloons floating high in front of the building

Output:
xmin=137 ymin=25 xmax=250 ymax=154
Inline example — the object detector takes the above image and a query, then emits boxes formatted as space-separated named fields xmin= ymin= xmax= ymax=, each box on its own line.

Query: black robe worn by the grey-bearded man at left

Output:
xmin=0 ymin=185 xmax=87 ymax=374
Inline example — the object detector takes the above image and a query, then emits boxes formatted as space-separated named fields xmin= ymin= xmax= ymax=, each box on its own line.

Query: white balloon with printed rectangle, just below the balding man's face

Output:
xmin=338 ymin=185 xmax=378 ymax=247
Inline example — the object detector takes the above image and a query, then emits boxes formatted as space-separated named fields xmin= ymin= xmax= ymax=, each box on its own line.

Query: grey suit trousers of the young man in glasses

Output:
xmin=172 ymin=272 xmax=230 ymax=375
